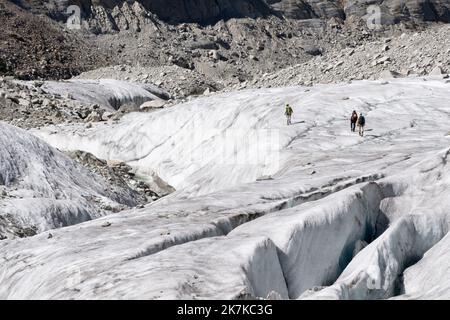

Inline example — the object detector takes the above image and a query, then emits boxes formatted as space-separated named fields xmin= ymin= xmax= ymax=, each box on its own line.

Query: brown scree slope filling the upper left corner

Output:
xmin=0 ymin=1 xmax=108 ymax=79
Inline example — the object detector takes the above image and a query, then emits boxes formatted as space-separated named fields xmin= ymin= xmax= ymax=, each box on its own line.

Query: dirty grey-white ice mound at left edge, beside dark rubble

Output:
xmin=0 ymin=122 xmax=142 ymax=237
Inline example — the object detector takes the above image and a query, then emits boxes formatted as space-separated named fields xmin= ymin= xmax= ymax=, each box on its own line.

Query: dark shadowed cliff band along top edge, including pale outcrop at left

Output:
xmin=62 ymin=0 xmax=450 ymax=32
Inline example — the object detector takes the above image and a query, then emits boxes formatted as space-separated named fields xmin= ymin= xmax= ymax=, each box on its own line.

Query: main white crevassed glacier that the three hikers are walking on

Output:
xmin=0 ymin=77 xmax=450 ymax=299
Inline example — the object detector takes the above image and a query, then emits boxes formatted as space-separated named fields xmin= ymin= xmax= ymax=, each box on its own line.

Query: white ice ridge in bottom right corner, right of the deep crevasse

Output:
xmin=302 ymin=149 xmax=450 ymax=299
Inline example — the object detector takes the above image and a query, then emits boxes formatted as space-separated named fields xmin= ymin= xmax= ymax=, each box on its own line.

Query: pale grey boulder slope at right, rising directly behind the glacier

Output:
xmin=253 ymin=25 xmax=450 ymax=87
